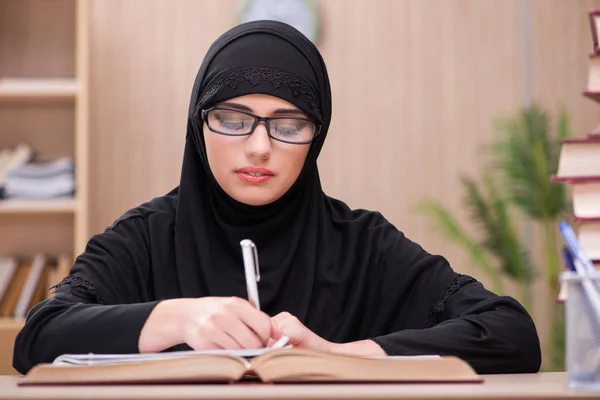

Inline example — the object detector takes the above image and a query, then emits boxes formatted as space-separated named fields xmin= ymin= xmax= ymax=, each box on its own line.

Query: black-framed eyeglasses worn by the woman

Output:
xmin=201 ymin=107 xmax=321 ymax=144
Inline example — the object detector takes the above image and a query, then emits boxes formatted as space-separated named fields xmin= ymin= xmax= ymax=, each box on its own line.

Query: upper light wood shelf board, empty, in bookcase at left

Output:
xmin=0 ymin=78 xmax=79 ymax=100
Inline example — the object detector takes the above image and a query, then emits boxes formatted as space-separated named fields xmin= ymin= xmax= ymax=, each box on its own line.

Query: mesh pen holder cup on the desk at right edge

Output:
xmin=561 ymin=272 xmax=600 ymax=392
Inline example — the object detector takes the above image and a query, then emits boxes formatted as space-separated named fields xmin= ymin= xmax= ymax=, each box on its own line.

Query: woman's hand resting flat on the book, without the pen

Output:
xmin=268 ymin=312 xmax=387 ymax=356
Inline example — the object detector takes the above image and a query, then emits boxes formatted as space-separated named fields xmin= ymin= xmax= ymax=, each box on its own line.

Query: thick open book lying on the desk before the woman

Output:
xmin=19 ymin=347 xmax=482 ymax=385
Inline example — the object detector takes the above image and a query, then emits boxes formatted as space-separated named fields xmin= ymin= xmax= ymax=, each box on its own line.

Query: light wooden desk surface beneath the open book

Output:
xmin=0 ymin=372 xmax=600 ymax=400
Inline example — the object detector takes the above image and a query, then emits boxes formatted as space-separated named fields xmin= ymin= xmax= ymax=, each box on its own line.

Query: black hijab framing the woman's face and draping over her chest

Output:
xmin=175 ymin=21 xmax=331 ymax=316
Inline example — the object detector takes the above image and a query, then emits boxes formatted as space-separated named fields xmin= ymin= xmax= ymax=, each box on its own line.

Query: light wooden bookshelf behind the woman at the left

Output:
xmin=0 ymin=0 xmax=89 ymax=374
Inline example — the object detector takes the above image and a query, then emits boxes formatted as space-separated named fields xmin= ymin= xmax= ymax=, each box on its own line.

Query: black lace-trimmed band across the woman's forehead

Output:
xmin=199 ymin=68 xmax=321 ymax=117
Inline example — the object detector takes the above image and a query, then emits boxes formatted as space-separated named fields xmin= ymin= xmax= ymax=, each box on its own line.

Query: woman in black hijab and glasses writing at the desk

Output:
xmin=14 ymin=21 xmax=540 ymax=373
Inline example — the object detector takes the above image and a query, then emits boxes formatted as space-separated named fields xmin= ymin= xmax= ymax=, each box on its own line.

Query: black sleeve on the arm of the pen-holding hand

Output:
xmin=13 ymin=219 xmax=162 ymax=373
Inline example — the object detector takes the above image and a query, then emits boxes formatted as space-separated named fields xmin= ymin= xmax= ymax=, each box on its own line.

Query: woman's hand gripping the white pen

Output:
xmin=139 ymin=297 xmax=281 ymax=353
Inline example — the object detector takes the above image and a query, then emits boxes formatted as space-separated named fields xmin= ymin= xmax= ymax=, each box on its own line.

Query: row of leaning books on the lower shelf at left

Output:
xmin=0 ymin=254 xmax=71 ymax=318
